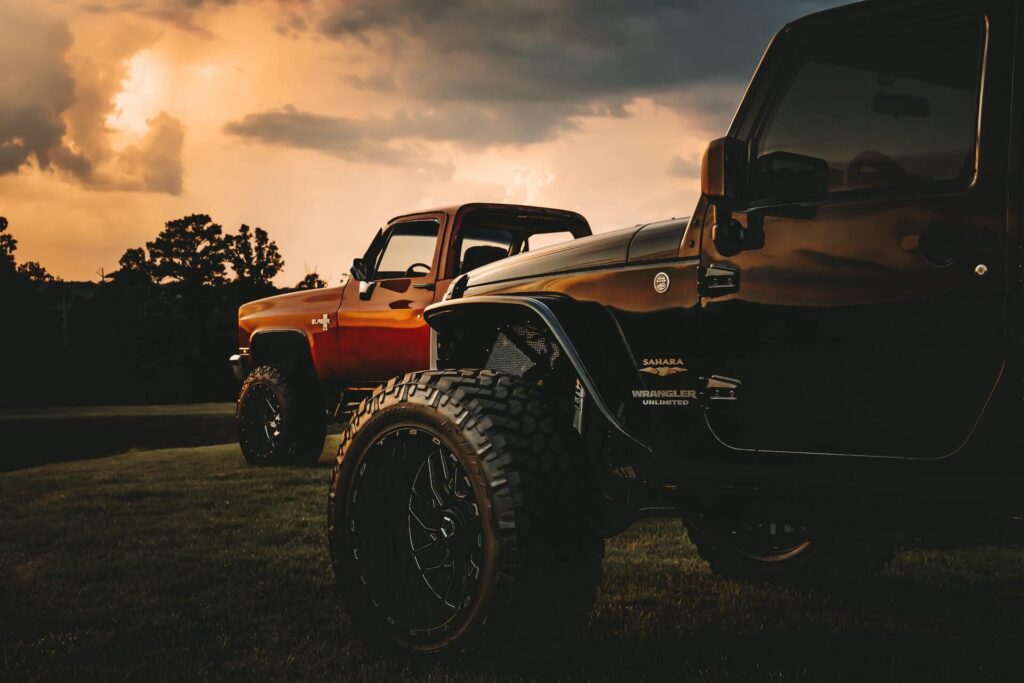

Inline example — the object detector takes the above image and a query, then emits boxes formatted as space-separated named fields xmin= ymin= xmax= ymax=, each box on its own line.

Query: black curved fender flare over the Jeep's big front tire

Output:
xmin=423 ymin=296 xmax=652 ymax=454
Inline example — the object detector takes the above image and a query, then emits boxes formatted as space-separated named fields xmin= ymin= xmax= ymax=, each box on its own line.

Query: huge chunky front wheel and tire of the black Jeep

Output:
xmin=328 ymin=371 xmax=604 ymax=668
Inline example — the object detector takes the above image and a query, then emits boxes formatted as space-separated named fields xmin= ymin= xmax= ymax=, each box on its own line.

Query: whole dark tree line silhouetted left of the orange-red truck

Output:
xmin=0 ymin=214 xmax=326 ymax=408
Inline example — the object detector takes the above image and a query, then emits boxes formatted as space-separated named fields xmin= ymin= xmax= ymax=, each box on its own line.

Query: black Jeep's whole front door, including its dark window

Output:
xmin=701 ymin=2 xmax=1016 ymax=459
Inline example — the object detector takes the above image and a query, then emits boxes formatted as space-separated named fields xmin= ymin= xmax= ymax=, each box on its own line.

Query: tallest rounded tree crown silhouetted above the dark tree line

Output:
xmin=146 ymin=213 xmax=227 ymax=285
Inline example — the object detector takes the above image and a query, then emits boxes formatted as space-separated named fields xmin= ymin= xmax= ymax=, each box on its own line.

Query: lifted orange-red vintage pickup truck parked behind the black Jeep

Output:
xmin=230 ymin=204 xmax=591 ymax=465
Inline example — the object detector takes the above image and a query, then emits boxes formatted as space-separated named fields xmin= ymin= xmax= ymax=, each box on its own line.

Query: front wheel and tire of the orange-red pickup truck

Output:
xmin=234 ymin=366 xmax=327 ymax=466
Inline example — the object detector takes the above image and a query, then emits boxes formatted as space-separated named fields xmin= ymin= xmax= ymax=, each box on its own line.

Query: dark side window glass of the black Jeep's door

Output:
xmin=752 ymin=17 xmax=984 ymax=201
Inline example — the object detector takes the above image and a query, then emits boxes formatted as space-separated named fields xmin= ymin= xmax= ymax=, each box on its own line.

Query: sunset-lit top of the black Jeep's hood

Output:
xmin=467 ymin=218 xmax=689 ymax=288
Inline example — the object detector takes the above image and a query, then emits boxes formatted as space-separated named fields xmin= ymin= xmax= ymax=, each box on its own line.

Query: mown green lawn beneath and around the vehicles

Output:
xmin=0 ymin=444 xmax=1024 ymax=681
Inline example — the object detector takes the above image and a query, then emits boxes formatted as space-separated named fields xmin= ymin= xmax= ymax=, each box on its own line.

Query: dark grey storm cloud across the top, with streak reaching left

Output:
xmin=226 ymin=0 xmax=840 ymax=161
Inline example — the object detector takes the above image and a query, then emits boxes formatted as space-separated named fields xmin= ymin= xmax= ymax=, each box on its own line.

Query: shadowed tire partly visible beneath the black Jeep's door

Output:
xmin=687 ymin=522 xmax=893 ymax=588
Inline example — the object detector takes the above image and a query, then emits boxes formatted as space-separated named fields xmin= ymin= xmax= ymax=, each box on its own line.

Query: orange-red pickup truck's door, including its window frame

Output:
xmin=337 ymin=214 xmax=444 ymax=387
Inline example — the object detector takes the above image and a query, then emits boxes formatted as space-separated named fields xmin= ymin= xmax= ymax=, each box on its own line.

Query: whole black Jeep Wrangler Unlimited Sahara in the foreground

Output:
xmin=329 ymin=0 xmax=1024 ymax=659
